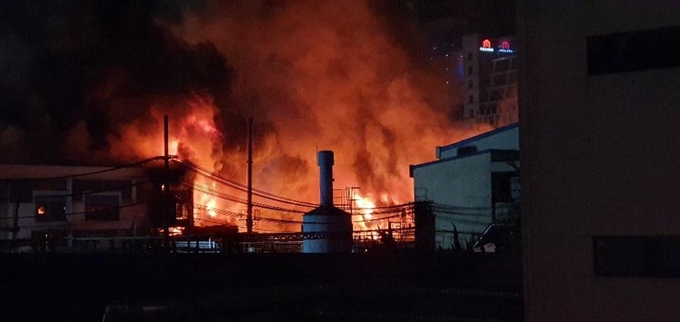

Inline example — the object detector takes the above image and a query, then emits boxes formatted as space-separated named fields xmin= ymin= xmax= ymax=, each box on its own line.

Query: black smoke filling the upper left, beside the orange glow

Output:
xmin=0 ymin=0 xmax=232 ymax=163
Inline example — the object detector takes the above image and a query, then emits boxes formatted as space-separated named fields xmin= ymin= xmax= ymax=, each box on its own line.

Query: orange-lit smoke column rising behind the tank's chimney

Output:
xmin=174 ymin=0 xmax=484 ymax=202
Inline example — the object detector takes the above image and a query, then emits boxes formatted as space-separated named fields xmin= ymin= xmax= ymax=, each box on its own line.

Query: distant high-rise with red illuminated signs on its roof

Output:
xmin=462 ymin=34 xmax=518 ymax=127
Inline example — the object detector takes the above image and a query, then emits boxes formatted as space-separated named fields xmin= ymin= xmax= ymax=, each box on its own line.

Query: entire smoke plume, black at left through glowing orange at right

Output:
xmin=0 ymin=0 xmax=488 ymax=230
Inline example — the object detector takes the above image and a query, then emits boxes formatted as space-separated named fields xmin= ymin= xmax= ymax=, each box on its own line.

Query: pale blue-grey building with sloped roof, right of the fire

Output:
xmin=410 ymin=123 xmax=520 ymax=249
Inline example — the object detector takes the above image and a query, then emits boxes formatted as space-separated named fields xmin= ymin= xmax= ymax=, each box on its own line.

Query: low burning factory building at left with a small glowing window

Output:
xmin=0 ymin=164 xmax=192 ymax=252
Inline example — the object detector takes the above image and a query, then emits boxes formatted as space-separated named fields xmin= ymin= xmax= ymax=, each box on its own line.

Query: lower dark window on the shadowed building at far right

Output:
xmin=593 ymin=236 xmax=680 ymax=277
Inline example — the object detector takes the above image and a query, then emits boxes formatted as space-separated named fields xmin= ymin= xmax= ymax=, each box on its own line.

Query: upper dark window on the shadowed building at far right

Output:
xmin=587 ymin=26 xmax=680 ymax=75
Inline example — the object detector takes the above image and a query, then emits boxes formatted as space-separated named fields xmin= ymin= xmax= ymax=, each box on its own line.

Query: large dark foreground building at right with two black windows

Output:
xmin=518 ymin=0 xmax=680 ymax=322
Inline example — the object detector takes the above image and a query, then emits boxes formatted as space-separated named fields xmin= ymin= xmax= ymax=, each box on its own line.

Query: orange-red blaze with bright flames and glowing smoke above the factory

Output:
xmin=41 ymin=0 xmax=486 ymax=231
